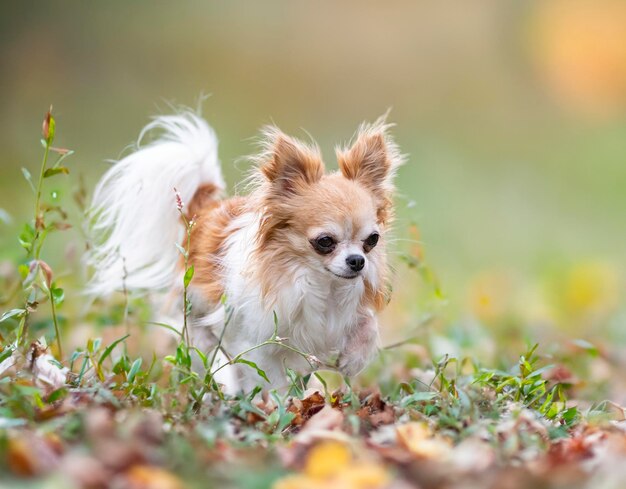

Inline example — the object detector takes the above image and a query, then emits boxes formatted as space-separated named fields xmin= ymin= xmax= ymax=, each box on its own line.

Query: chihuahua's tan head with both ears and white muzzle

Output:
xmin=252 ymin=117 xmax=401 ymax=302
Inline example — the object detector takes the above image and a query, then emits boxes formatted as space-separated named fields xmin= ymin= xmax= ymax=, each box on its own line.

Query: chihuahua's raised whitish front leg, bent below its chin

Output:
xmin=337 ymin=311 xmax=379 ymax=377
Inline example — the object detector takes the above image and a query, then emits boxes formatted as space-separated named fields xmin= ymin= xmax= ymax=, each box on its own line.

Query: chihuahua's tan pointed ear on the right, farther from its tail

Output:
xmin=336 ymin=115 xmax=404 ymax=199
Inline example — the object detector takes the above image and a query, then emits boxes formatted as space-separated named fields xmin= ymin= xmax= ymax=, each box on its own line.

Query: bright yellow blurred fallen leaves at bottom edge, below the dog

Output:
xmin=273 ymin=441 xmax=390 ymax=489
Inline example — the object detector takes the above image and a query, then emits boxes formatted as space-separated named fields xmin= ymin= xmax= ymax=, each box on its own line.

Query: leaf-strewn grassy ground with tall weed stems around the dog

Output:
xmin=0 ymin=111 xmax=624 ymax=489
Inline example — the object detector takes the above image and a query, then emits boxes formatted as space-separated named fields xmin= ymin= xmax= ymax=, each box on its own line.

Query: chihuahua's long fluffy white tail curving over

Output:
xmin=87 ymin=112 xmax=225 ymax=295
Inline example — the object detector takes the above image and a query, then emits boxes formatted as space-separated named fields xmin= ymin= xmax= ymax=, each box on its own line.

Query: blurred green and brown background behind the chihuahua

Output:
xmin=0 ymin=0 xmax=626 ymax=388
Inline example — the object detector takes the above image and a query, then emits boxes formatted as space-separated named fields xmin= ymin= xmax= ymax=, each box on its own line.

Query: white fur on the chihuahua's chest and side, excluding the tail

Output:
xmin=207 ymin=214 xmax=364 ymax=386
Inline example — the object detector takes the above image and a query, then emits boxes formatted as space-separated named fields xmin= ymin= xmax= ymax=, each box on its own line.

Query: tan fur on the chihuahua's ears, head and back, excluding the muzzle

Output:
xmin=190 ymin=119 xmax=401 ymax=311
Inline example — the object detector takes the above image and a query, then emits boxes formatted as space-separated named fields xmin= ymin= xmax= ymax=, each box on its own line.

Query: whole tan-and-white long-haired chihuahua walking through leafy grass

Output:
xmin=88 ymin=111 xmax=403 ymax=391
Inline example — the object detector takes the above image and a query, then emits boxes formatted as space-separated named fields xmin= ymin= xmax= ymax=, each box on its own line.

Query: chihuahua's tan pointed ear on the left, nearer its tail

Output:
xmin=259 ymin=126 xmax=324 ymax=194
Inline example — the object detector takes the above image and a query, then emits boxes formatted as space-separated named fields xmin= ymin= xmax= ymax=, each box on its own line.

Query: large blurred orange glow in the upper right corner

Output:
xmin=529 ymin=0 xmax=626 ymax=115
